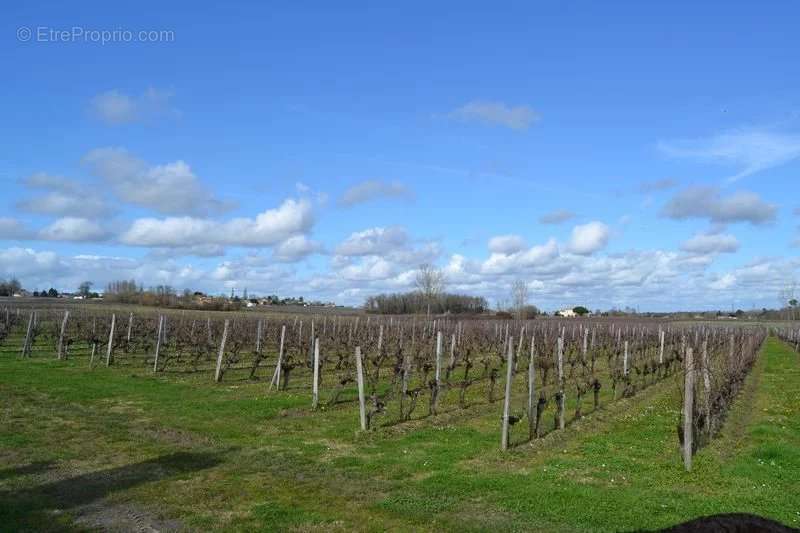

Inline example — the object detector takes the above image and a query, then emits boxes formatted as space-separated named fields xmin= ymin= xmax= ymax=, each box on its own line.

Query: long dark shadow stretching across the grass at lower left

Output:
xmin=0 ymin=452 xmax=222 ymax=530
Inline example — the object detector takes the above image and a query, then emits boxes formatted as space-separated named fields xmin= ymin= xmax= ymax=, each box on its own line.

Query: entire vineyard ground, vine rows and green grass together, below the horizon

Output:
xmin=0 ymin=302 xmax=800 ymax=531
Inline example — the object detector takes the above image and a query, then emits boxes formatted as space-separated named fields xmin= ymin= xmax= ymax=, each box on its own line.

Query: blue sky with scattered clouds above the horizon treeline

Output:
xmin=0 ymin=1 xmax=800 ymax=311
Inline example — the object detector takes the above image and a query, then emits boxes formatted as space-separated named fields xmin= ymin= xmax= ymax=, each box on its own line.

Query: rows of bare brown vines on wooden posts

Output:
xmin=0 ymin=307 xmax=772 ymax=462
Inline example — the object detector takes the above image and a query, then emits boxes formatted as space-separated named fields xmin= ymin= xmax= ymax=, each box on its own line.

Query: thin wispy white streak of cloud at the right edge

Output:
xmin=658 ymin=129 xmax=800 ymax=182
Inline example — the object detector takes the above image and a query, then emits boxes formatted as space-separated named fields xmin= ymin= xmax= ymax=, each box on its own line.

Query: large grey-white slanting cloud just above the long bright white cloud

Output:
xmin=83 ymin=148 xmax=231 ymax=215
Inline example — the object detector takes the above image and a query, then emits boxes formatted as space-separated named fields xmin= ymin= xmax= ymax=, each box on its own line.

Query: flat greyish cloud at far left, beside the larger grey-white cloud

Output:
xmin=17 ymin=172 xmax=109 ymax=218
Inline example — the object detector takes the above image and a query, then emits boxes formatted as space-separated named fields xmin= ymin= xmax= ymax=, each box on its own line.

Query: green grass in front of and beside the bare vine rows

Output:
xmin=0 ymin=332 xmax=800 ymax=531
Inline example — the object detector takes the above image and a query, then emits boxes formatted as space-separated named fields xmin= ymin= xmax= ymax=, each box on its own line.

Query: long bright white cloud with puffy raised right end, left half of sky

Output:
xmin=120 ymin=199 xmax=314 ymax=247
